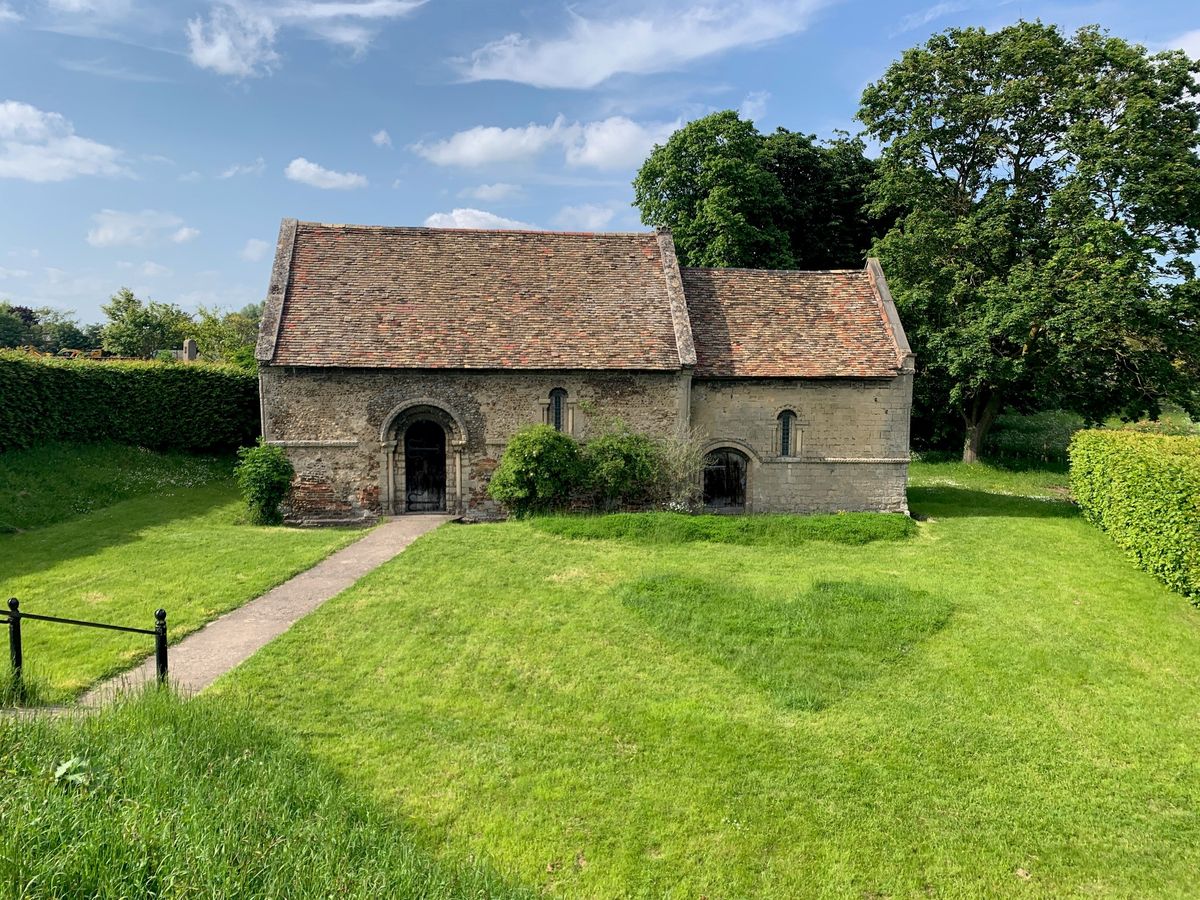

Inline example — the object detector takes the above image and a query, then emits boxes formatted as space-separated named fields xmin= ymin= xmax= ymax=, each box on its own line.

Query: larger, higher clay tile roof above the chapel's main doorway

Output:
xmin=258 ymin=220 xmax=691 ymax=370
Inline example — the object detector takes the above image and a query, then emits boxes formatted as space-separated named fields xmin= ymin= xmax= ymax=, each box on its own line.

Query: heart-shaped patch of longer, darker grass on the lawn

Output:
xmin=616 ymin=575 xmax=952 ymax=712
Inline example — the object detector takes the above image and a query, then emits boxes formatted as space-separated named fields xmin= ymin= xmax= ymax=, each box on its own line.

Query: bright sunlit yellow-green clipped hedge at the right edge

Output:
xmin=1070 ymin=430 xmax=1200 ymax=605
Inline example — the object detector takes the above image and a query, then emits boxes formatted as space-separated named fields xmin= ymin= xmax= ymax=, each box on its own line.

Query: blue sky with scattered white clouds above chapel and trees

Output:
xmin=0 ymin=0 xmax=1200 ymax=322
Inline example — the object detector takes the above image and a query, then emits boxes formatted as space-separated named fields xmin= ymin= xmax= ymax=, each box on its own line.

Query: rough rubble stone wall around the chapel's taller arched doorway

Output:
xmin=260 ymin=366 xmax=686 ymax=522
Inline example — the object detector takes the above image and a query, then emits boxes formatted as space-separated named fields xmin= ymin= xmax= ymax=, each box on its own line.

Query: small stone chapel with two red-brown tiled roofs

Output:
xmin=256 ymin=220 xmax=913 ymax=522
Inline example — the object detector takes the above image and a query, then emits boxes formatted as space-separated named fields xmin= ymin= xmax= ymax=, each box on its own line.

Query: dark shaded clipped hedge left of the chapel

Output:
xmin=0 ymin=352 xmax=259 ymax=451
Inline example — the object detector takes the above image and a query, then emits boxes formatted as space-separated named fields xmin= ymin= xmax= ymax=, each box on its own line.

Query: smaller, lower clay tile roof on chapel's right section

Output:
xmin=680 ymin=266 xmax=908 ymax=378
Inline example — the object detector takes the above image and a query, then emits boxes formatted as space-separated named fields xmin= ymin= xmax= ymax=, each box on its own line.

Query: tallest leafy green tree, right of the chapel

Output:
xmin=859 ymin=22 xmax=1200 ymax=461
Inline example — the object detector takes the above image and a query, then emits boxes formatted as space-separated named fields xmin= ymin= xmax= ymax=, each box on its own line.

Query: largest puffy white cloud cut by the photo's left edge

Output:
xmin=0 ymin=100 xmax=128 ymax=181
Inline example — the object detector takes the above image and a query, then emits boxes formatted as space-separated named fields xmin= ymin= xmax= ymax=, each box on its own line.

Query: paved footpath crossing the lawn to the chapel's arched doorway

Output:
xmin=79 ymin=516 xmax=454 ymax=707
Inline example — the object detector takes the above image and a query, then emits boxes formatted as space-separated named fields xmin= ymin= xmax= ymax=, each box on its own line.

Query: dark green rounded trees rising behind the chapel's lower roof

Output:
xmin=634 ymin=110 xmax=890 ymax=269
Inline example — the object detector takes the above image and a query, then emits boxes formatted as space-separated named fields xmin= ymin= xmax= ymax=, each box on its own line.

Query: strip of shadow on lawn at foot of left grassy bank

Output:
xmin=0 ymin=484 xmax=236 ymax=580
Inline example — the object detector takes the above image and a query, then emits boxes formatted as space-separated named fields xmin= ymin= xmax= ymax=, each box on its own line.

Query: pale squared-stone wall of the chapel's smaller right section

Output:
xmin=691 ymin=374 xmax=912 ymax=512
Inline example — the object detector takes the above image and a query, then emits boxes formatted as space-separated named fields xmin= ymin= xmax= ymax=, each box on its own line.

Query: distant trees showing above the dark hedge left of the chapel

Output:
xmin=0 ymin=288 xmax=263 ymax=368
